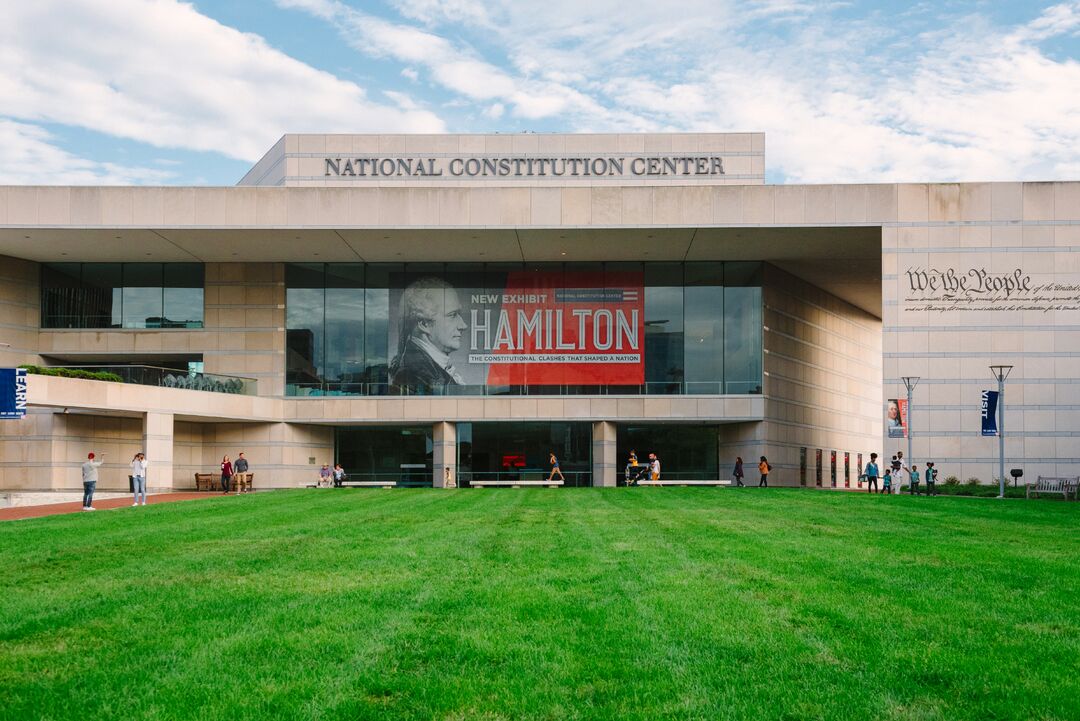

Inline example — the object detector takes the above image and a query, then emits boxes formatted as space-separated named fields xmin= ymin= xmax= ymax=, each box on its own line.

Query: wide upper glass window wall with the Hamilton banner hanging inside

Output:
xmin=285 ymin=262 xmax=762 ymax=395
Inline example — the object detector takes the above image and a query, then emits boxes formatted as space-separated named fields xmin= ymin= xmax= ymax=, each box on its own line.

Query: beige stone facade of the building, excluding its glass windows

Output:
xmin=0 ymin=134 xmax=1080 ymax=496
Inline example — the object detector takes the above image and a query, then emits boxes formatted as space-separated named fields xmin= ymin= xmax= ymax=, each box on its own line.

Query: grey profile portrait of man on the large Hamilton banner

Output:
xmin=389 ymin=277 xmax=469 ymax=389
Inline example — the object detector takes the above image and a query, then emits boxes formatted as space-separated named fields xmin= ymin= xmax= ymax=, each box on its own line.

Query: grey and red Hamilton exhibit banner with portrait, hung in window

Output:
xmin=389 ymin=271 xmax=645 ymax=385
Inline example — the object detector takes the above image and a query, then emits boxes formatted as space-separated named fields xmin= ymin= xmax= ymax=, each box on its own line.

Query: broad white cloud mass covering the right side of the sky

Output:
xmin=332 ymin=0 xmax=1080 ymax=182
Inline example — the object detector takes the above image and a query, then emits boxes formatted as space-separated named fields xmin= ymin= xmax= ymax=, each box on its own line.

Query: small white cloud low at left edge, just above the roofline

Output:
xmin=0 ymin=118 xmax=175 ymax=186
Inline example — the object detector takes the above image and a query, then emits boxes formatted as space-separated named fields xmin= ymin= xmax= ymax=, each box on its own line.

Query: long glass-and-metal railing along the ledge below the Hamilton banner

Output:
xmin=285 ymin=381 xmax=761 ymax=397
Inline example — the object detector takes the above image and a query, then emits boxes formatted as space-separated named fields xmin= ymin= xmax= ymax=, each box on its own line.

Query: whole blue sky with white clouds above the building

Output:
xmin=0 ymin=0 xmax=1080 ymax=185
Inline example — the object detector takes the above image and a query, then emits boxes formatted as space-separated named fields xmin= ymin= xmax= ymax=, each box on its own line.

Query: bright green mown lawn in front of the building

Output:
xmin=0 ymin=488 xmax=1080 ymax=721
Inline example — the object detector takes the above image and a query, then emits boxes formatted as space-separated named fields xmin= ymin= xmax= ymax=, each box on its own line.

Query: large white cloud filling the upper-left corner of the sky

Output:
xmin=0 ymin=0 xmax=444 ymax=161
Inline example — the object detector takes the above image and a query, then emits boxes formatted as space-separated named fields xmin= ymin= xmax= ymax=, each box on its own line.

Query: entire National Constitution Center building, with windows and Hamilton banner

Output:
xmin=0 ymin=133 xmax=1080 ymax=492
